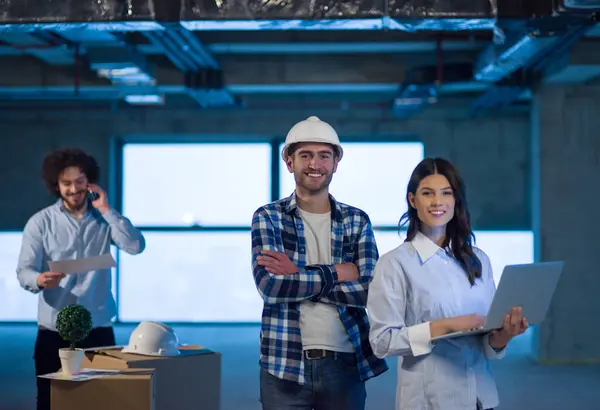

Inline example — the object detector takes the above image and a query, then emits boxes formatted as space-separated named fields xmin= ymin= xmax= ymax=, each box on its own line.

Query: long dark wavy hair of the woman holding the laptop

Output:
xmin=398 ymin=158 xmax=481 ymax=285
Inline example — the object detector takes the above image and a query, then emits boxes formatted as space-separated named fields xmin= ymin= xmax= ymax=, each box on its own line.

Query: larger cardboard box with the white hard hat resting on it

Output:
xmin=81 ymin=348 xmax=221 ymax=410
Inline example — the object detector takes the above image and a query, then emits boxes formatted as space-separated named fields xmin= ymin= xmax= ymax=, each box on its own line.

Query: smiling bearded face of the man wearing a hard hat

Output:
xmin=286 ymin=143 xmax=338 ymax=195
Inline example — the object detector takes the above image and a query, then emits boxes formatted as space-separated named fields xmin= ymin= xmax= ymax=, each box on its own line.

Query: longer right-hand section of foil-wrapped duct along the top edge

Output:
xmin=181 ymin=0 xmax=495 ymax=31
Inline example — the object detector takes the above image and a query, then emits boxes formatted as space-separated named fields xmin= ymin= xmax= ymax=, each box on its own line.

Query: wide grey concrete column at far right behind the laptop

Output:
xmin=531 ymin=86 xmax=600 ymax=364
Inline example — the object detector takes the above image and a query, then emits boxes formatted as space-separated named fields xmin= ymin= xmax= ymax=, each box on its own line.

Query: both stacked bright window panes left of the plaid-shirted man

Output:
xmin=118 ymin=143 xmax=273 ymax=322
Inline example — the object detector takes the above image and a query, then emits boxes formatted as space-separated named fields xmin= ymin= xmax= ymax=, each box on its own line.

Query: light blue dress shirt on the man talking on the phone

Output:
xmin=17 ymin=199 xmax=146 ymax=330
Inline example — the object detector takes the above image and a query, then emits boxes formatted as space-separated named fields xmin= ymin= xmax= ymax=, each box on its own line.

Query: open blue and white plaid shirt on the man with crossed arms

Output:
xmin=252 ymin=194 xmax=388 ymax=384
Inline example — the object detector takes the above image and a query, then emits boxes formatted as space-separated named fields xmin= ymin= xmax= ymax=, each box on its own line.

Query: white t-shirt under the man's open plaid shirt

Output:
xmin=298 ymin=208 xmax=354 ymax=352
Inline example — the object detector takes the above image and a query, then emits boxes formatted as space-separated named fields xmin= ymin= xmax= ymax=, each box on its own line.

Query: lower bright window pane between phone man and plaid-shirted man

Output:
xmin=119 ymin=232 xmax=263 ymax=322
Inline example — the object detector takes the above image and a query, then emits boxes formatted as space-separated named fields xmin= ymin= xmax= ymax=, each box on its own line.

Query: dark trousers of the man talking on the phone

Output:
xmin=33 ymin=327 xmax=116 ymax=410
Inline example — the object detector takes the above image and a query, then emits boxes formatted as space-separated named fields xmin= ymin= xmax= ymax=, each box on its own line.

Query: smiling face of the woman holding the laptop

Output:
xmin=408 ymin=174 xmax=456 ymax=229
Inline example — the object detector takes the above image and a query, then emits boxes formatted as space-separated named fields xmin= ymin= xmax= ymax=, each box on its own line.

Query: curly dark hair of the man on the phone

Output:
xmin=42 ymin=148 xmax=100 ymax=197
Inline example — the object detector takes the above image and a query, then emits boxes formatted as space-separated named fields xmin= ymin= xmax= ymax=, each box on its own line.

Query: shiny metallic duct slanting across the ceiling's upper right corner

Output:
xmin=472 ymin=0 xmax=600 ymax=112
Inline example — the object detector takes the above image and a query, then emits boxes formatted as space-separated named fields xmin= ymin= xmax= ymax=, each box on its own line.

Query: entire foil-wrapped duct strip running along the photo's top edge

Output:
xmin=0 ymin=0 xmax=496 ymax=31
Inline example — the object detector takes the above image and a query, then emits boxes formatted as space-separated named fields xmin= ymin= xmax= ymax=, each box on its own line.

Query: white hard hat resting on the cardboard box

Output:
xmin=121 ymin=322 xmax=179 ymax=356
